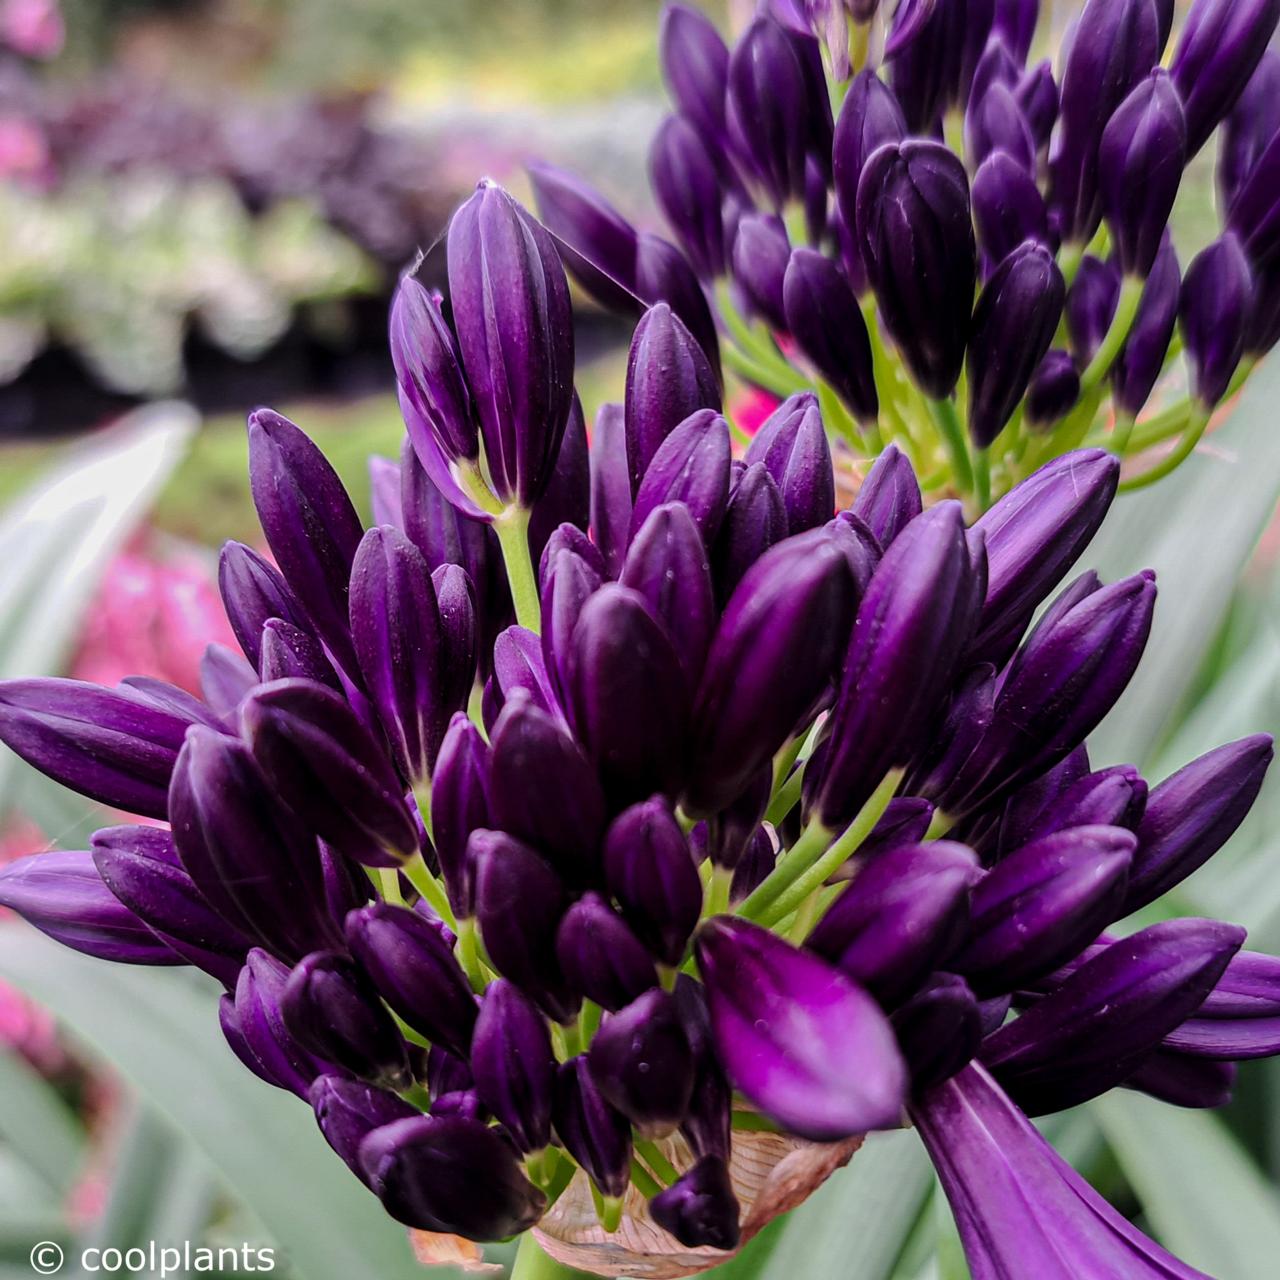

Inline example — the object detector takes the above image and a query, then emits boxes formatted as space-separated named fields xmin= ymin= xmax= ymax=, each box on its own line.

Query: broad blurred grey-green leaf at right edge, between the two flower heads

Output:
xmin=1087 ymin=362 xmax=1280 ymax=764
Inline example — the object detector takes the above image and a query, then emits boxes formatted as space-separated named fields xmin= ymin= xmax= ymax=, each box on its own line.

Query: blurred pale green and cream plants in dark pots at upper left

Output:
xmin=0 ymin=173 xmax=375 ymax=396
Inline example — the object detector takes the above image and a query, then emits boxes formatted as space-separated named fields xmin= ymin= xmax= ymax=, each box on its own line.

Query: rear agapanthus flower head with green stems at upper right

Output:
xmin=532 ymin=0 xmax=1280 ymax=512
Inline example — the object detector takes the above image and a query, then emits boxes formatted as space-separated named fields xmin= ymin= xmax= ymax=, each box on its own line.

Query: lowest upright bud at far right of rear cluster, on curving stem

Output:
xmin=1179 ymin=232 xmax=1253 ymax=408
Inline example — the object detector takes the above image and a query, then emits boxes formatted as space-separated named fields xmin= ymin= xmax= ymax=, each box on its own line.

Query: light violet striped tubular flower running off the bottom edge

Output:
xmin=911 ymin=1059 xmax=1204 ymax=1280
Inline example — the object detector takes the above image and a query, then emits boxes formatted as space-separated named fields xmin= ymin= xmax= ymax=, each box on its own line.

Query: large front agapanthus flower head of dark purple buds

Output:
xmin=0 ymin=180 xmax=1280 ymax=1277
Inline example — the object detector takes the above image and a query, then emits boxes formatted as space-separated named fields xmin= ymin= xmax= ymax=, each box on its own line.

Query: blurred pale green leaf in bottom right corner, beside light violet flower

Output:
xmin=1091 ymin=1091 xmax=1280 ymax=1280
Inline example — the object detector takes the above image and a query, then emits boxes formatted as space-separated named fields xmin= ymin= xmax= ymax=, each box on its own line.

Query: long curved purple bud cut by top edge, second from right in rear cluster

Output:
xmin=1050 ymin=0 xmax=1162 ymax=244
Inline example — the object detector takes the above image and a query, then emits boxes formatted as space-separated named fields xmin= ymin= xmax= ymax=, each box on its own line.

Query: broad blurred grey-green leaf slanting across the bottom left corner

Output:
xmin=0 ymin=925 xmax=448 ymax=1280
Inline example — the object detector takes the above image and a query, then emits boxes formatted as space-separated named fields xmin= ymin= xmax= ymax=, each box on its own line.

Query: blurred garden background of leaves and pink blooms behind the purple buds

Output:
xmin=0 ymin=0 xmax=1280 ymax=1280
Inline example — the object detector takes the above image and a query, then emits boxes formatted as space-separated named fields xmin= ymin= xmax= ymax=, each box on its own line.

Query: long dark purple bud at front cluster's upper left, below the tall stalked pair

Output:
xmin=248 ymin=408 xmax=364 ymax=677
